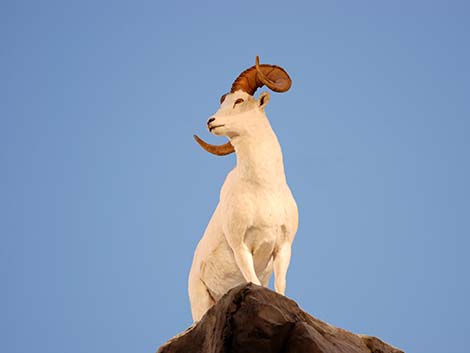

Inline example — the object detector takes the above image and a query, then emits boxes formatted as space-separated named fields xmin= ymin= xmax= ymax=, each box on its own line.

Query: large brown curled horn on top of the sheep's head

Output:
xmin=230 ymin=56 xmax=292 ymax=95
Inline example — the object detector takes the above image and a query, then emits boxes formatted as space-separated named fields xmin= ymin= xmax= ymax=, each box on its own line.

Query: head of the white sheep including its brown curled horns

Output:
xmin=194 ymin=56 xmax=292 ymax=156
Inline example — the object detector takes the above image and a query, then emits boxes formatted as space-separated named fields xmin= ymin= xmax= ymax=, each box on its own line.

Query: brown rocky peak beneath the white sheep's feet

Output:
xmin=158 ymin=283 xmax=403 ymax=353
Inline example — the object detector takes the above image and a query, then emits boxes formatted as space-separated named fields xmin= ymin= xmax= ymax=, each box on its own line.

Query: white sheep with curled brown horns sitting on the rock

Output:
xmin=188 ymin=57 xmax=298 ymax=322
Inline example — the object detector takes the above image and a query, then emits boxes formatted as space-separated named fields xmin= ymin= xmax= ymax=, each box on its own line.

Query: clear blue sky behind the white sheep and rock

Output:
xmin=0 ymin=0 xmax=470 ymax=353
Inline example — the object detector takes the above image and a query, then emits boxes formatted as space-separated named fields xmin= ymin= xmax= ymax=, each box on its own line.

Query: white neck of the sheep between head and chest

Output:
xmin=232 ymin=129 xmax=286 ymax=188
